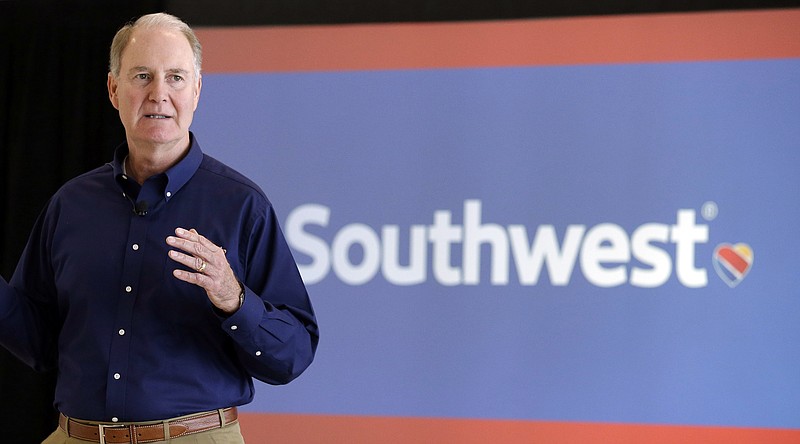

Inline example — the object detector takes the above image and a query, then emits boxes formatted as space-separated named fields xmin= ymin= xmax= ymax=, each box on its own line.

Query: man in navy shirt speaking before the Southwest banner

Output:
xmin=0 ymin=14 xmax=319 ymax=443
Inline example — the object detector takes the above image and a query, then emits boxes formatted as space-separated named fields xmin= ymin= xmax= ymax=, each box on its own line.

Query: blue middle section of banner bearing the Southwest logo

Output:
xmin=193 ymin=59 xmax=800 ymax=428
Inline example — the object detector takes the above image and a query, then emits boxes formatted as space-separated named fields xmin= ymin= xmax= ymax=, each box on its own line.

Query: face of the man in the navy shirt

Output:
xmin=108 ymin=28 xmax=202 ymax=150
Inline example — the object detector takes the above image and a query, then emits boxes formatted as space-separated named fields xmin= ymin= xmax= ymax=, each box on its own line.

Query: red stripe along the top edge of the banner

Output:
xmin=197 ymin=9 xmax=800 ymax=73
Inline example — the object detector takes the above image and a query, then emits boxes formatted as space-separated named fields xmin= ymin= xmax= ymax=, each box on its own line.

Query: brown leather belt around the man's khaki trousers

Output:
xmin=58 ymin=407 xmax=239 ymax=444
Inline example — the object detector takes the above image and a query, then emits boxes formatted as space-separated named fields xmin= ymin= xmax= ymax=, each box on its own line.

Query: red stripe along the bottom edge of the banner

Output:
xmin=240 ymin=413 xmax=800 ymax=444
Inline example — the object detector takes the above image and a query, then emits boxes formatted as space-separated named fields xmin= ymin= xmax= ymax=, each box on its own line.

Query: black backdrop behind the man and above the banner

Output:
xmin=0 ymin=0 xmax=800 ymax=444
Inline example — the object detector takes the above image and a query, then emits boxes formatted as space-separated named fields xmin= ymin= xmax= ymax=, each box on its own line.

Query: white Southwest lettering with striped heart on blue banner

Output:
xmin=285 ymin=199 xmax=753 ymax=288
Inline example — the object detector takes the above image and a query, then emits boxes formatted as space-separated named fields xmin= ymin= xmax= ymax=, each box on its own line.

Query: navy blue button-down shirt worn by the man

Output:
xmin=0 ymin=135 xmax=319 ymax=421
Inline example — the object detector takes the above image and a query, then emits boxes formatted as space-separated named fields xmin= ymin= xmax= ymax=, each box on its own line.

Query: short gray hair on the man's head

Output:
xmin=108 ymin=12 xmax=203 ymax=79
